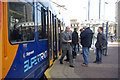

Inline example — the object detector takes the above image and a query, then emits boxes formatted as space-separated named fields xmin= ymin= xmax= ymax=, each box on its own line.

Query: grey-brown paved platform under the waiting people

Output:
xmin=47 ymin=43 xmax=120 ymax=79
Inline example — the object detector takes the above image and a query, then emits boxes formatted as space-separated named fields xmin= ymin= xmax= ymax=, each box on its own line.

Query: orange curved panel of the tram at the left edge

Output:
xmin=2 ymin=2 xmax=18 ymax=78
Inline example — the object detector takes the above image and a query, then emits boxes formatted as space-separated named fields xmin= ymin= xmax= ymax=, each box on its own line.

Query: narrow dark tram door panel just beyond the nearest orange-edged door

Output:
xmin=52 ymin=15 xmax=57 ymax=60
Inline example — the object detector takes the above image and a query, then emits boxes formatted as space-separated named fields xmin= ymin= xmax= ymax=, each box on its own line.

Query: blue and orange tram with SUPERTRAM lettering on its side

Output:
xmin=0 ymin=0 xmax=61 ymax=79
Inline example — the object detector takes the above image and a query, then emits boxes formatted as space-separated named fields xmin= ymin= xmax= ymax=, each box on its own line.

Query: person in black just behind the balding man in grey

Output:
xmin=72 ymin=28 xmax=78 ymax=58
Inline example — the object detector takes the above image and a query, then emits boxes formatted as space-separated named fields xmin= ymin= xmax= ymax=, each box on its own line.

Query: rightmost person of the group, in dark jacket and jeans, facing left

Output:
xmin=93 ymin=27 xmax=106 ymax=64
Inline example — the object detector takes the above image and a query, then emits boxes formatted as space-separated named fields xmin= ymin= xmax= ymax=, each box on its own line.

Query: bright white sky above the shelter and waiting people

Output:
xmin=52 ymin=0 xmax=117 ymax=25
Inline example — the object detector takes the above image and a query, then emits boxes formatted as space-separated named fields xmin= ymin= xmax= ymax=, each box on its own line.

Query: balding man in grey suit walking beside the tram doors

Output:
xmin=60 ymin=26 xmax=74 ymax=68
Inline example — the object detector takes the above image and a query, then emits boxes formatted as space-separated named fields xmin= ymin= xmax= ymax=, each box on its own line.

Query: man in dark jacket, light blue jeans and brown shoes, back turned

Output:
xmin=80 ymin=26 xmax=93 ymax=67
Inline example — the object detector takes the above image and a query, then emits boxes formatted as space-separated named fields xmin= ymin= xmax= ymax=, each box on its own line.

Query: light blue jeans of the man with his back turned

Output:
xmin=82 ymin=47 xmax=90 ymax=65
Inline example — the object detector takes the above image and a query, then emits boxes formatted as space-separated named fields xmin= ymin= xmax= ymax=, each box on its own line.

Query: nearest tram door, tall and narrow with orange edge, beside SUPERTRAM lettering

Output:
xmin=48 ymin=8 xmax=53 ymax=66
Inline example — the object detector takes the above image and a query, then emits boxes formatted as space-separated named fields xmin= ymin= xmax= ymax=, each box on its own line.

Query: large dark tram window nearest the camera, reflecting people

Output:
xmin=8 ymin=2 xmax=35 ymax=43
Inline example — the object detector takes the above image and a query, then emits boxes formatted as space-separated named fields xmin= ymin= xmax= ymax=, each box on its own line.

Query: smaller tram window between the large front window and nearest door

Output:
xmin=38 ymin=7 xmax=48 ymax=40
